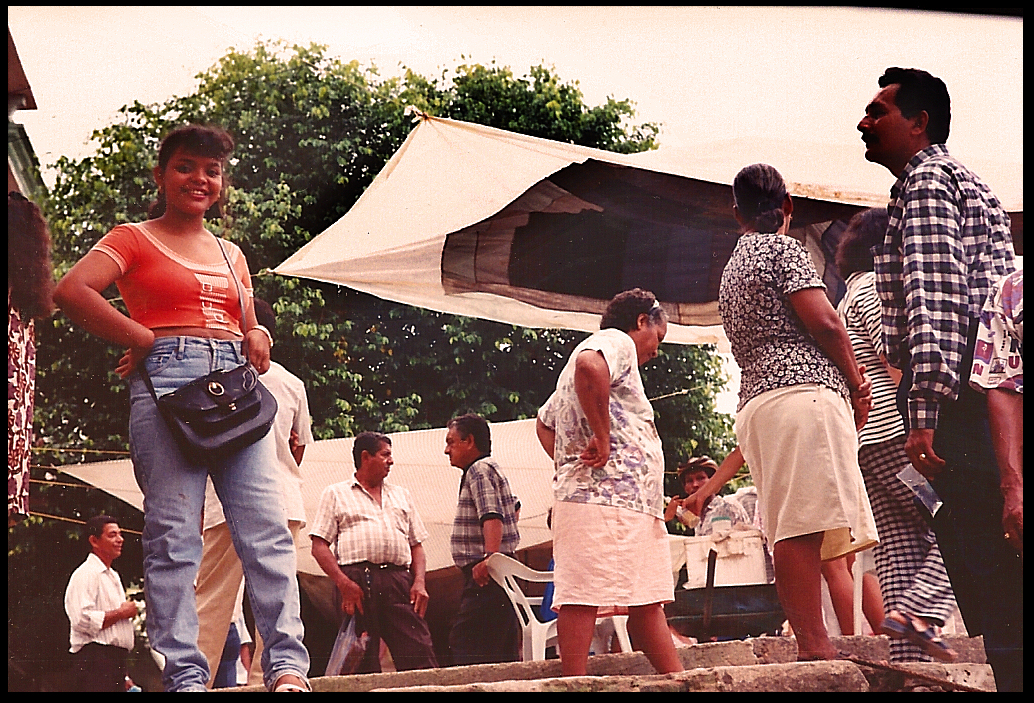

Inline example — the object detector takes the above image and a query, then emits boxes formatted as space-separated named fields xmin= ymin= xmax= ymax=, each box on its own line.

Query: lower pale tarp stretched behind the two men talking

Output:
xmin=61 ymin=420 xmax=553 ymax=576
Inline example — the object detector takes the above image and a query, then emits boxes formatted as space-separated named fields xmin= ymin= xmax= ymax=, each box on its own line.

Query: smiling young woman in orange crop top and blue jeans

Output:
xmin=55 ymin=125 xmax=309 ymax=691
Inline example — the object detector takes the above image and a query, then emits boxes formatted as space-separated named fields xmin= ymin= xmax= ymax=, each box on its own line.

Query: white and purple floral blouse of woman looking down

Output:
xmin=539 ymin=330 xmax=664 ymax=518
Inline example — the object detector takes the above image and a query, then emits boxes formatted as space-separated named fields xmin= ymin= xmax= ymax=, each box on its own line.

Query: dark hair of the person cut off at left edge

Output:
xmin=7 ymin=190 xmax=54 ymax=318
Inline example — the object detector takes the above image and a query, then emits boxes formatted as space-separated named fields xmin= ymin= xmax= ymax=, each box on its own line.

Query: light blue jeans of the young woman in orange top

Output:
xmin=129 ymin=337 xmax=309 ymax=691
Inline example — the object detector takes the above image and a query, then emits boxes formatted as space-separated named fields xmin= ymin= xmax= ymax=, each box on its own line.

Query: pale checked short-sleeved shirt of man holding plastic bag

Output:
xmin=309 ymin=478 xmax=427 ymax=568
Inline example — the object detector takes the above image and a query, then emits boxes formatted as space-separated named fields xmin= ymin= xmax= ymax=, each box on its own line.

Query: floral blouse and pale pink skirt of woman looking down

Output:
xmin=539 ymin=330 xmax=674 ymax=616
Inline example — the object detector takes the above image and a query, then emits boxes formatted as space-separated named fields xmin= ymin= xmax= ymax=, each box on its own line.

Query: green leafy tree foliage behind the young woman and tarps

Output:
xmin=8 ymin=36 xmax=731 ymax=686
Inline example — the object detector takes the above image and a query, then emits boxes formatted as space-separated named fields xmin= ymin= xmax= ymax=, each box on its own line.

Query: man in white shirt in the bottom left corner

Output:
xmin=65 ymin=515 xmax=136 ymax=693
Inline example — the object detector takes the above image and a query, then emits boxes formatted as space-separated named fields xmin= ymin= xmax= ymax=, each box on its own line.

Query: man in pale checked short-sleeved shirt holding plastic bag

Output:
xmin=309 ymin=432 xmax=438 ymax=674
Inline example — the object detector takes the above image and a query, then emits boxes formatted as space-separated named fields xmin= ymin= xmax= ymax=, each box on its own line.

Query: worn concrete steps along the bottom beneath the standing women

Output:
xmin=231 ymin=636 xmax=995 ymax=692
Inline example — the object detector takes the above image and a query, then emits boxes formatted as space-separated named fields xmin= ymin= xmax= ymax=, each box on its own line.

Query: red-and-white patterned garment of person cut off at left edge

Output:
xmin=7 ymin=291 xmax=36 ymax=521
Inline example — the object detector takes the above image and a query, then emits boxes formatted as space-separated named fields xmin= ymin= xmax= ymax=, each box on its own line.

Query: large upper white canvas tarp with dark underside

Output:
xmin=275 ymin=111 xmax=1023 ymax=345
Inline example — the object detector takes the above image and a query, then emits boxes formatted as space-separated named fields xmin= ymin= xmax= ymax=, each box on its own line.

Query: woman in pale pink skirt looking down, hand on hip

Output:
xmin=536 ymin=288 xmax=682 ymax=676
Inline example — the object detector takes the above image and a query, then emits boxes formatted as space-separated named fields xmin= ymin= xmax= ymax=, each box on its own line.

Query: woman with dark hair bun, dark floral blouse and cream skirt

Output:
xmin=719 ymin=163 xmax=877 ymax=660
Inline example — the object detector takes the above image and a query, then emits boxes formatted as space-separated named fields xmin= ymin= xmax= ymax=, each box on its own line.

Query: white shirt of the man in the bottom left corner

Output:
xmin=65 ymin=552 xmax=134 ymax=654
